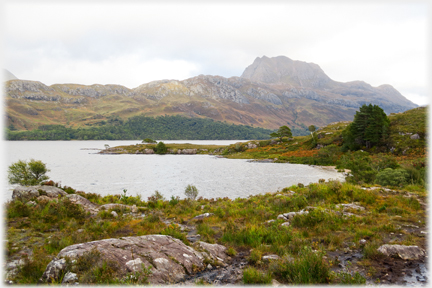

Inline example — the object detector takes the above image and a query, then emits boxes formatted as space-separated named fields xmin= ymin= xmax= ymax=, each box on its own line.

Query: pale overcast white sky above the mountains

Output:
xmin=1 ymin=0 xmax=429 ymax=105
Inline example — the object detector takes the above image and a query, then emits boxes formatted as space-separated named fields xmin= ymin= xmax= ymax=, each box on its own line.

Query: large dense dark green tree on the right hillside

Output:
xmin=342 ymin=104 xmax=390 ymax=151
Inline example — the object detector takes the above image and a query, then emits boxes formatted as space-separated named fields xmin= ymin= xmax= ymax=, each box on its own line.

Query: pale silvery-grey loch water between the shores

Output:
xmin=2 ymin=140 xmax=344 ymax=201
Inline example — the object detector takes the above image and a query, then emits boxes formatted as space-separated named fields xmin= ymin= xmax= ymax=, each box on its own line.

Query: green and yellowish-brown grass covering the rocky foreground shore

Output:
xmin=5 ymin=177 xmax=426 ymax=284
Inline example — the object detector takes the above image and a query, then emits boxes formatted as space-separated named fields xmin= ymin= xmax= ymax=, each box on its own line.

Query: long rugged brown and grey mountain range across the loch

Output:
xmin=5 ymin=56 xmax=417 ymax=129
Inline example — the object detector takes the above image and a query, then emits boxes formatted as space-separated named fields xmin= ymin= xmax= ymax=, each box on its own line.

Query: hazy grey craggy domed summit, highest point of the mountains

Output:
xmin=241 ymin=56 xmax=332 ymax=88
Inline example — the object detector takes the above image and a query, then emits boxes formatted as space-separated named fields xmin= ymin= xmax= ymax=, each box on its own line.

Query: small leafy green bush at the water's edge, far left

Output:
xmin=8 ymin=159 xmax=50 ymax=186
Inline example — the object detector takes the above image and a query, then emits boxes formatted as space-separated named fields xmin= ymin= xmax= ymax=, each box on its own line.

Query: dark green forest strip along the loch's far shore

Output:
xmin=6 ymin=116 xmax=284 ymax=140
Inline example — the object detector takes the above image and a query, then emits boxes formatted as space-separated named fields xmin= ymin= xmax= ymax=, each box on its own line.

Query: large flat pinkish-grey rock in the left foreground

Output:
xmin=41 ymin=235 xmax=228 ymax=285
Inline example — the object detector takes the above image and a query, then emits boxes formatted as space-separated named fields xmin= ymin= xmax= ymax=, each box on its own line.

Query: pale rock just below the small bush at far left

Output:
xmin=12 ymin=185 xmax=68 ymax=202
